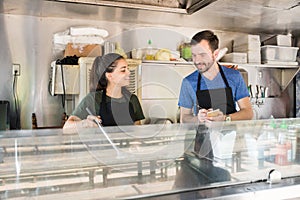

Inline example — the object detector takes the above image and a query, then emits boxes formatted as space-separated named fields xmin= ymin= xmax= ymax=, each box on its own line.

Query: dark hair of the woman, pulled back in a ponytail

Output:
xmin=89 ymin=53 xmax=124 ymax=92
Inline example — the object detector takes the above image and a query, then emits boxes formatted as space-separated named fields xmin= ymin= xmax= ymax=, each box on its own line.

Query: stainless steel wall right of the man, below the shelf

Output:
xmin=224 ymin=63 xmax=300 ymax=119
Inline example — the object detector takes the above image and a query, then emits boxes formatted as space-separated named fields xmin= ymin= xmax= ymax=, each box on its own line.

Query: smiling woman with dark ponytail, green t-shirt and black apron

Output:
xmin=63 ymin=53 xmax=145 ymax=133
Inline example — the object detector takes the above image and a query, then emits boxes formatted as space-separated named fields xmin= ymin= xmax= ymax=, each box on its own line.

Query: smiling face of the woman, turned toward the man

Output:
xmin=106 ymin=59 xmax=130 ymax=87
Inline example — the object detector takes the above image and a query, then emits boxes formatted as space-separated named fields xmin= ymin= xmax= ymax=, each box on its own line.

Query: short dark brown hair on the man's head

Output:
xmin=191 ymin=30 xmax=219 ymax=52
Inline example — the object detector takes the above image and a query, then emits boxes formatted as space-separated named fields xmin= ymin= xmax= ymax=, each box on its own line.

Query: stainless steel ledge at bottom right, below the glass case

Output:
xmin=135 ymin=177 xmax=300 ymax=200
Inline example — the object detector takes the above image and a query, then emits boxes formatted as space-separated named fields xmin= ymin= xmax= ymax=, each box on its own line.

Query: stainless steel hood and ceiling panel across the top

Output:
xmin=1 ymin=0 xmax=300 ymax=35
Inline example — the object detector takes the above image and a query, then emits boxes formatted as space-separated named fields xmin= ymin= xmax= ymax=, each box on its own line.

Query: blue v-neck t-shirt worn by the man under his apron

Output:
xmin=178 ymin=66 xmax=249 ymax=115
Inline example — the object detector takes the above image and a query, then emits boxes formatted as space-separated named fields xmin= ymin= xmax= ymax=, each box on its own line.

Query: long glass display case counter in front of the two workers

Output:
xmin=0 ymin=118 xmax=300 ymax=200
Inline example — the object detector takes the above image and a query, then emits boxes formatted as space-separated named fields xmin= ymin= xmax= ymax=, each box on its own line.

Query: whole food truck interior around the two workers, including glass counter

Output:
xmin=0 ymin=0 xmax=300 ymax=199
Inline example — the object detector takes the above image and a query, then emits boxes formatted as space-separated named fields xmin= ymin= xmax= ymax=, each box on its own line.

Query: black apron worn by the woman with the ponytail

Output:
xmin=99 ymin=91 xmax=135 ymax=126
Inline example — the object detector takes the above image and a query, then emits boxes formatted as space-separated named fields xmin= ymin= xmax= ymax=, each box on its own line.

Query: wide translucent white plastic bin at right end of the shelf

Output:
xmin=261 ymin=45 xmax=299 ymax=62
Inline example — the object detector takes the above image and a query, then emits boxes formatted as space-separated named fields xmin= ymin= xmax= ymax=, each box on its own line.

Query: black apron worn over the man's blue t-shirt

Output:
xmin=196 ymin=66 xmax=236 ymax=115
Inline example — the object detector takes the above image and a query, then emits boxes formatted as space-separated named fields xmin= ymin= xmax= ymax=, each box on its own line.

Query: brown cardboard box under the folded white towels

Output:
xmin=64 ymin=43 xmax=102 ymax=57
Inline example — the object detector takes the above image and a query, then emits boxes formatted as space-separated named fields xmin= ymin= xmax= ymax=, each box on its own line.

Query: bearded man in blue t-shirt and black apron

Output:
xmin=178 ymin=30 xmax=253 ymax=123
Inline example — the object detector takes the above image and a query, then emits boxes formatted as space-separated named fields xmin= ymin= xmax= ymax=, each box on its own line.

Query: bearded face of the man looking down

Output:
xmin=191 ymin=40 xmax=218 ymax=73
